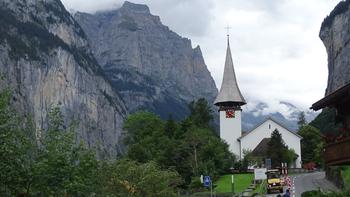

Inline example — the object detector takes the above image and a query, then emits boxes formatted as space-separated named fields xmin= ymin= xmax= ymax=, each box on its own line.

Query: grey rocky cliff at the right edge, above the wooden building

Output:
xmin=320 ymin=0 xmax=350 ymax=95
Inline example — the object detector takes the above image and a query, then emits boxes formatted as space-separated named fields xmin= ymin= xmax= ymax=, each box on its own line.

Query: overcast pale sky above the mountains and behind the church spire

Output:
xmin=62 ymin=0 xmax=340 ymax=114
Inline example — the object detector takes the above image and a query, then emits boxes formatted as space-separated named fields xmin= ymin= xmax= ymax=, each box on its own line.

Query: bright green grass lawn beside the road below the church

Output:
xmin=215 ymin=174 xmax=254 ymax=193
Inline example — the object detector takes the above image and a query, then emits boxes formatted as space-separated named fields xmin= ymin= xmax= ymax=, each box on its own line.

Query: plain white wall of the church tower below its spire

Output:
xmin=220 ymin=110 xmax=242 ymax=159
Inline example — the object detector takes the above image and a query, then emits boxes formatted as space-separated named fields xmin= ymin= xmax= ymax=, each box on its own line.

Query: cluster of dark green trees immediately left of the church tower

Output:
xmin=124 ymin=99 xmax=234 ymax=188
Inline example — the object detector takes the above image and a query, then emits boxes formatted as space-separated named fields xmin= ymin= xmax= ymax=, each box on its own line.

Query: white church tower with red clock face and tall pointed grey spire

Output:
xmin=214 ymin=35 xmax=246 ymax=158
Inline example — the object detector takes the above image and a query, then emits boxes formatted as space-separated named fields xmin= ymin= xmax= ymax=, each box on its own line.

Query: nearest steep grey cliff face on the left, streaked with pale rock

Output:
xmin=0 ymin=0 xmax=127 ymax=157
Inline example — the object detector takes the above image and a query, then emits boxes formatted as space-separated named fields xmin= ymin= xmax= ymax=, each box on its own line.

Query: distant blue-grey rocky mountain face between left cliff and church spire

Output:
xmin=74 ymin=2 xmax=217 ymax=119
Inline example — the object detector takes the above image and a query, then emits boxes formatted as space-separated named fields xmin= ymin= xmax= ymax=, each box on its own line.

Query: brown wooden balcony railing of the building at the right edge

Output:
xmin=325 ymin=137 xmax=350 ymax=165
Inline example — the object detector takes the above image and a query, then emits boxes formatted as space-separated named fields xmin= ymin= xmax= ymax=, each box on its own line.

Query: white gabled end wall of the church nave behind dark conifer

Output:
xmin=241 ymin=119 xmax=301 ymax=168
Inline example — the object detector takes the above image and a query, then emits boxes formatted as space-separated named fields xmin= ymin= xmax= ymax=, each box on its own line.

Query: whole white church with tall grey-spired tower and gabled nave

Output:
xmin=214 ymin=36 xmax=302 ymax=168
